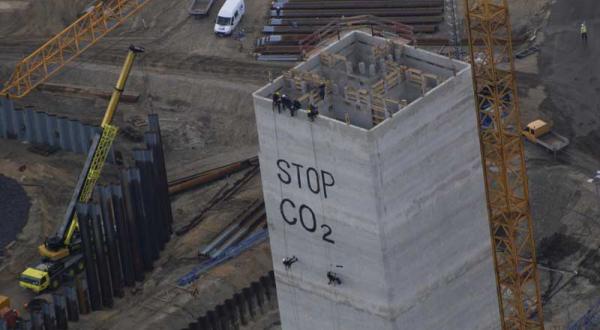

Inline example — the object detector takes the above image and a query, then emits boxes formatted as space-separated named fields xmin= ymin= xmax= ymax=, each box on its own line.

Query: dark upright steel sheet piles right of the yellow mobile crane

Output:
xmin=77 ymin=115 xmax=173 ymax=310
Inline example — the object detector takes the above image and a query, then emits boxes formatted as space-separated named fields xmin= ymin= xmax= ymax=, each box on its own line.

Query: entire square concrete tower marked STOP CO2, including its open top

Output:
xmin=254 ymin=31 xmax=499 ymax=330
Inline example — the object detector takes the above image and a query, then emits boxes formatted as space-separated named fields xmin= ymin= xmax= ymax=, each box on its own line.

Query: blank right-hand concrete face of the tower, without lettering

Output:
xmin=371 ymin=65 xmax=500 ymax=329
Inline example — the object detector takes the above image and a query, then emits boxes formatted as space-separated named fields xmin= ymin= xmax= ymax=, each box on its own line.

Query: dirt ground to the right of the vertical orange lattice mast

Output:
xmin=521 ymin=0 xmax=600 ymax=326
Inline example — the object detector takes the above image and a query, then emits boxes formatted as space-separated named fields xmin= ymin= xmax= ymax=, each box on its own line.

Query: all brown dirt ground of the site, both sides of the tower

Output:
xmin=0 ymin=0 xmax=600 ymax=329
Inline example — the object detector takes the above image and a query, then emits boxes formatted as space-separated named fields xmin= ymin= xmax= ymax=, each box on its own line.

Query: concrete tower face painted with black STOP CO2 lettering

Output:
xmin=255 ymin=94 xmax=391 ymax=329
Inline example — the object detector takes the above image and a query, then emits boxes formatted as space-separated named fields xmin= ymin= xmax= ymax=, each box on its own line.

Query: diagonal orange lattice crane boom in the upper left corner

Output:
xmin=0 ymin=0 xmax=149 ymax=99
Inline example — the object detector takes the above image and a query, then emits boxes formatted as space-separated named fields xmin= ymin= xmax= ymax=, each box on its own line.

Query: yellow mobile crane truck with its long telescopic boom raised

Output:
xmin=19 ymin=46 xmax=144 ymax=293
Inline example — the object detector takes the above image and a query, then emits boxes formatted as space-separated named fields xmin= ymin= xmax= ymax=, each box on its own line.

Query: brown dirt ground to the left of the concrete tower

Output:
xmin=0 ymin=0 xmax=288 ymax=329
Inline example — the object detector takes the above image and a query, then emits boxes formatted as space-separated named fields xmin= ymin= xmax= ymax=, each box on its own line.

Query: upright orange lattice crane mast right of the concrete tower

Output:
xmin=465 ymin=0 xmax=544 ymax=329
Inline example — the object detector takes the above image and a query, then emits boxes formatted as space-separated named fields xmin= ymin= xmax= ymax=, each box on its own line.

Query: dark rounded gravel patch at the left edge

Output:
xmin=0 ymin=174 xmax=31 ymax=250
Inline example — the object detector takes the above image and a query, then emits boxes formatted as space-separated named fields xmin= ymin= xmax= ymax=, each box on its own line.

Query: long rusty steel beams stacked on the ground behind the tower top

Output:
xmin=255 ymin=0 xmax=444 ymax=60
